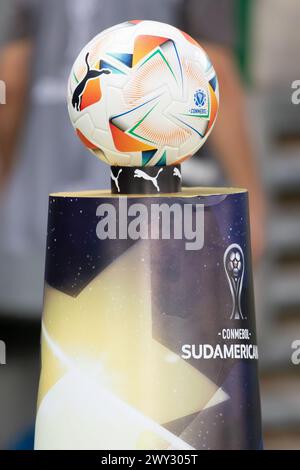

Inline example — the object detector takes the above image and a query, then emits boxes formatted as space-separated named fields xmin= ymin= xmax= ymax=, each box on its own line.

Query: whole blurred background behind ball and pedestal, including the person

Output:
xmin=0 ymin=0 xmax=300 ymax=449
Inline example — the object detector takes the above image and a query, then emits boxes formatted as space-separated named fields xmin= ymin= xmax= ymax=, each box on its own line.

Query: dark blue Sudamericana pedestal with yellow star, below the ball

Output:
xmin=35 ymin=188 xmax=262 ymax=450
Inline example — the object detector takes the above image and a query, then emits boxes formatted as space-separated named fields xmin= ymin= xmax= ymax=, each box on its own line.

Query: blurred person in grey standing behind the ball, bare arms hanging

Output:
xmin=0 ymin=0 xmax=264 ymax=320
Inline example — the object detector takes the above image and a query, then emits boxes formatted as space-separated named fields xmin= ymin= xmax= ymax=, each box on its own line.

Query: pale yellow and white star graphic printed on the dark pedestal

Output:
xmin=35 ymin=242 xmax=228 ymax=450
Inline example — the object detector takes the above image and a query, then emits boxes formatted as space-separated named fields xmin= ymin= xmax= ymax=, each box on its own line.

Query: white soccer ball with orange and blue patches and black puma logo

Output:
xmin=68 ymin=21 xmax=219 ymax=167
